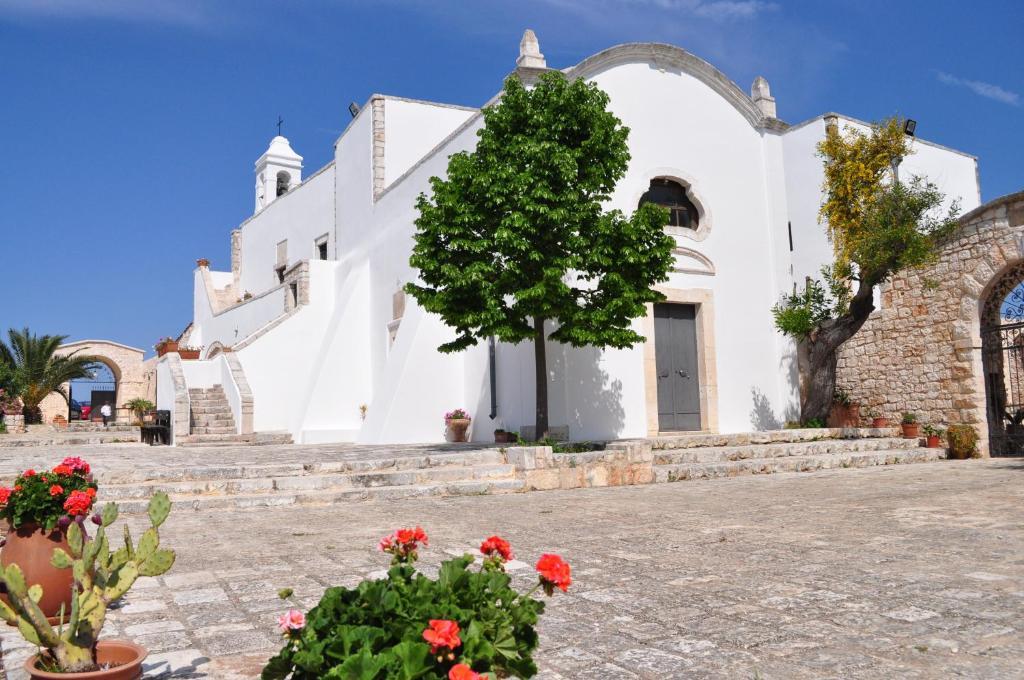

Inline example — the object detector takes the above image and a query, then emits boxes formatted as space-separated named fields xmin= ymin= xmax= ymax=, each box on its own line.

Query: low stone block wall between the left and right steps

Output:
xmin=506 ymin=442 xmax=654 ymax=491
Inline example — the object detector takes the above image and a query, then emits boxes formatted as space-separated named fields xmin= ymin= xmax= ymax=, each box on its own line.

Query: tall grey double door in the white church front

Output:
xmin=654 ymin=304 xmax=700 ymax=432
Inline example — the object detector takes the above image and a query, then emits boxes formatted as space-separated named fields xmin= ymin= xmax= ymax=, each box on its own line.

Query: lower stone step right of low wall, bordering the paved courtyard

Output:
xmin=654 ymin=447 xmax=946 ymax=482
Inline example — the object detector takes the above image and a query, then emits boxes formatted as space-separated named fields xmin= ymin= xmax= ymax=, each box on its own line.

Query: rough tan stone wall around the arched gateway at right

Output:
xmin=839 ymin=192 xmax=1024 ymax=455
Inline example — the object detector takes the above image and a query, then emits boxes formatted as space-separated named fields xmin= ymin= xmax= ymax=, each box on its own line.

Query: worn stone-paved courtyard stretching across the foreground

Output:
xmin=4 ymin=452 xmax=1024 ymax=680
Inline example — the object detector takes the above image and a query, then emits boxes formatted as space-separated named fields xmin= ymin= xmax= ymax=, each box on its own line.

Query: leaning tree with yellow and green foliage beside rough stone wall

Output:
xmin=772 ymin=118 xmax=957 ymax=422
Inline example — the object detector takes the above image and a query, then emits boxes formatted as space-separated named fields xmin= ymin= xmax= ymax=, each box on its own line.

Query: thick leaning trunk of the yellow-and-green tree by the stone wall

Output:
xmin=800 ymin=282 xmax=874 ymax=425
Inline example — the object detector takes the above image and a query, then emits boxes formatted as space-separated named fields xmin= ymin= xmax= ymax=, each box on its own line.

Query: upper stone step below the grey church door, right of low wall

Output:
xmin=653 ymin=437 xmax=919 ymax=465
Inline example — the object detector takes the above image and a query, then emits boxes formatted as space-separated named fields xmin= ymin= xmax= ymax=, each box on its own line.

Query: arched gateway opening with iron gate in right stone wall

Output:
xmin=981 ymin=261 xmax=1024 ymax=456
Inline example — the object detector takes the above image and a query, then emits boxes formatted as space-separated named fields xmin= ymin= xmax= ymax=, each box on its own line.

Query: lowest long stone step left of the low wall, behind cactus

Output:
xmin=118 ymin=478 xmax=523 ymax=513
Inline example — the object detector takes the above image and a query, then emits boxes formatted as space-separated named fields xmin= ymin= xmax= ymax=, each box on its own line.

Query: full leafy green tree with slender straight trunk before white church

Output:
xmin=406 ymin=72 xmax=674 ymax=437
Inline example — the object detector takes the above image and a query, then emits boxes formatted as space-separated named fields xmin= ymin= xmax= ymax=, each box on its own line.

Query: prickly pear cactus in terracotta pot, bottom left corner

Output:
xmin=0 ymin=492 xmax=174 ymax=680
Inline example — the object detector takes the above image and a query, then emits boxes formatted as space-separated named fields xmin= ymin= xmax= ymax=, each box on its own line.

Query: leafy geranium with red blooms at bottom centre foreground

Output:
xmin=261 ymin=526 xmax=572 ymax=680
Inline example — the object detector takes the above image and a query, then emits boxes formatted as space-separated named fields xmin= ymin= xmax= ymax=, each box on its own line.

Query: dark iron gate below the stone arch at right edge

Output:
xmin=981 ymin=322 xmax=1024 ymax=456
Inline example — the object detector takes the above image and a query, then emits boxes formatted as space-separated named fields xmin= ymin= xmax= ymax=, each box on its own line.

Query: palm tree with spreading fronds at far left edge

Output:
xmin=0 ymin=328 xmax=96 ymax=423
